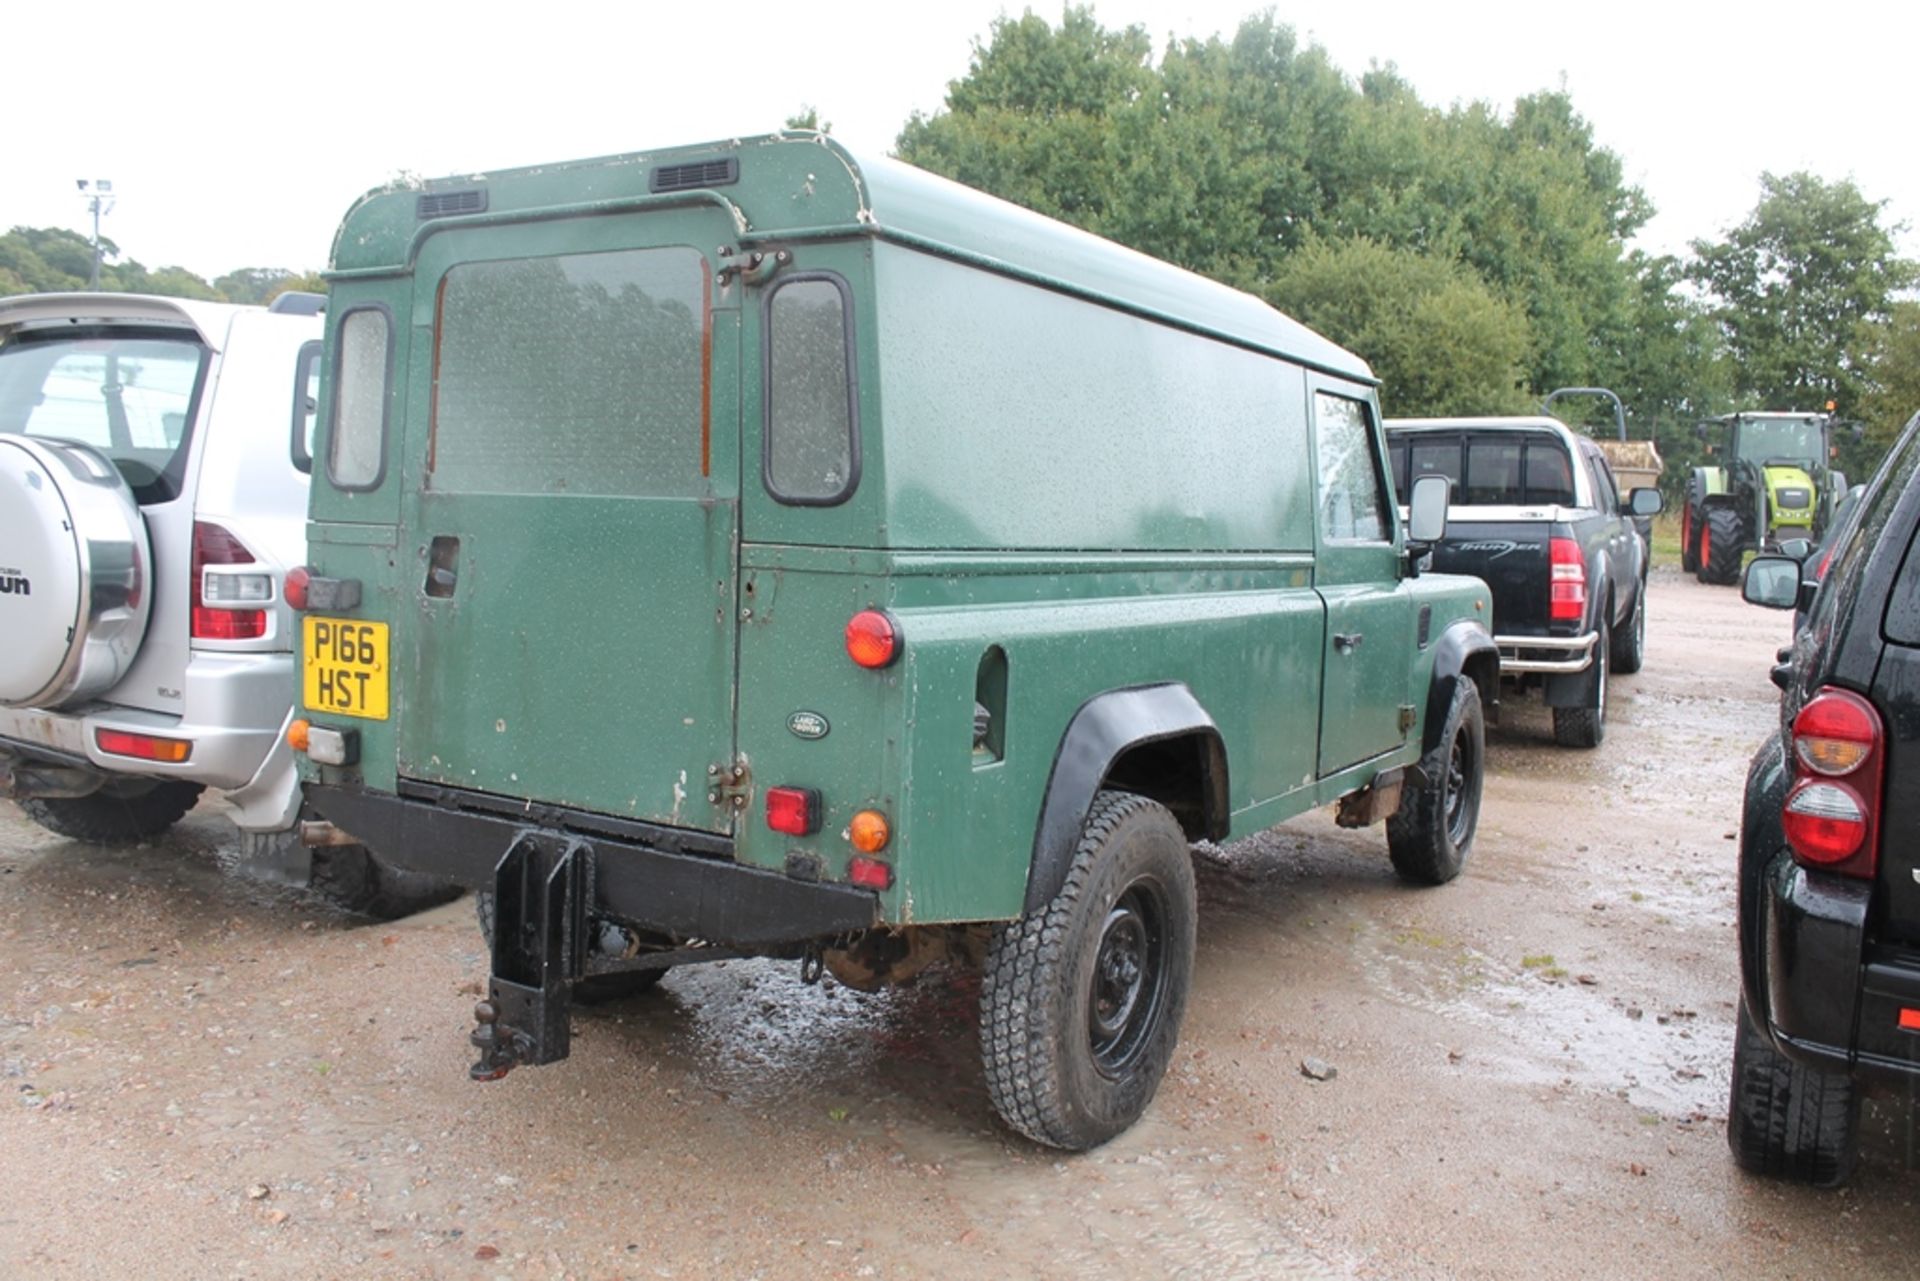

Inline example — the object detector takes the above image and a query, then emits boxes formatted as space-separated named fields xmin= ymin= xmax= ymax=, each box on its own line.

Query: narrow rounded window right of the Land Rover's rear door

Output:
xmin=760 ymin=273 xmax=860 ymax=507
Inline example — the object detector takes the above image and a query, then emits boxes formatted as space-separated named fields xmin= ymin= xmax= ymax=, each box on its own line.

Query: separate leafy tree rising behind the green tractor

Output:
xmin=1688 ymin=173 xmax=1920 ymax=417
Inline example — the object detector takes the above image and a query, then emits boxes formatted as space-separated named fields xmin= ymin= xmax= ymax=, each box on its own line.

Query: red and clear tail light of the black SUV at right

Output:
xmin=1780 ymin=686 xmax=1885 ymax=880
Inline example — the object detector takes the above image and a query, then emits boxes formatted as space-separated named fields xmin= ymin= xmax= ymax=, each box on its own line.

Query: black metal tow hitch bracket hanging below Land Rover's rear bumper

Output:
xmin=468 ymin=832 xmax=593 ymax=1081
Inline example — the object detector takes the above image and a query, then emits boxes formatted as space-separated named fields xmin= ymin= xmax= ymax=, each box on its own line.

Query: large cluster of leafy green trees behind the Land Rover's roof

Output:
xmin=897 ymin=8 xmax=1666 ymax=420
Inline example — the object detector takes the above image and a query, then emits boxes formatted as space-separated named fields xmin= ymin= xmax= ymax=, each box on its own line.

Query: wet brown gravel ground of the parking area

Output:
xmin=0 ymin=572 xmax=1920 ymax=1279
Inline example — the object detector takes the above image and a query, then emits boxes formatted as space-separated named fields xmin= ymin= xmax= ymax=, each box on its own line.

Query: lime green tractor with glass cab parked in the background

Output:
xmin=1680 ymin=413 xmax=1847 ymax=584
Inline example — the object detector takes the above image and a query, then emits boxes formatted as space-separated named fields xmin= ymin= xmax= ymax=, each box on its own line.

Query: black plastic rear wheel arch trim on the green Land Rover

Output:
xmin=1023 ymin=682 xmax=1231 ymax=912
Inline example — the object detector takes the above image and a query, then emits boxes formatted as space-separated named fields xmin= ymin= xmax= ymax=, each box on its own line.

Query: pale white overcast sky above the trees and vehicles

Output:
xmin=0 ymin=0 xmax=1920 ymax=278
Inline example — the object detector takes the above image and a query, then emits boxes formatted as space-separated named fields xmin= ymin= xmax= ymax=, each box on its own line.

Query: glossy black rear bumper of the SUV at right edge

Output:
xmin=1761 ymin=851 xmax=1920 ymax=1077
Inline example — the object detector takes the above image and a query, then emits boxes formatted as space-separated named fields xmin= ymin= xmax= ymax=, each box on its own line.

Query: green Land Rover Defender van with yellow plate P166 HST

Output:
xmin=288 ymin=133 xmax=1498 ymax=1148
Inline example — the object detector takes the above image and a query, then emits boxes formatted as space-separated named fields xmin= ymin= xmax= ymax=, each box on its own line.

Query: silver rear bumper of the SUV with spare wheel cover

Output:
xmin=0 ymin=653 xmax=300 ymax=830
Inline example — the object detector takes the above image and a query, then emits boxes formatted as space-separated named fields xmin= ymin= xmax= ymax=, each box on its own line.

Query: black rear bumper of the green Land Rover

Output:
xmin=307 ymin=784 xmax=879 ymax=953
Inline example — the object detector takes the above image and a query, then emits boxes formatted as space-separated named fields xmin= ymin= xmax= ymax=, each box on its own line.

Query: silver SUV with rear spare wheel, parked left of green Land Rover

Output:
xmin=0 ymin=294 xmax=445 ymax=914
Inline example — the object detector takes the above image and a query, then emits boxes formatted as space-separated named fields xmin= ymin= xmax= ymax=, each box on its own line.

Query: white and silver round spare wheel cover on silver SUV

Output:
xmin=0 ymin=436 xmax=152 ymax=707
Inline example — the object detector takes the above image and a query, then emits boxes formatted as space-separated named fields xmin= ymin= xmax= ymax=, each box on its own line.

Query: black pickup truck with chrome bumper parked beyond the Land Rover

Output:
xmin=1386 ymin=417 xmax=1661 ymax=747
